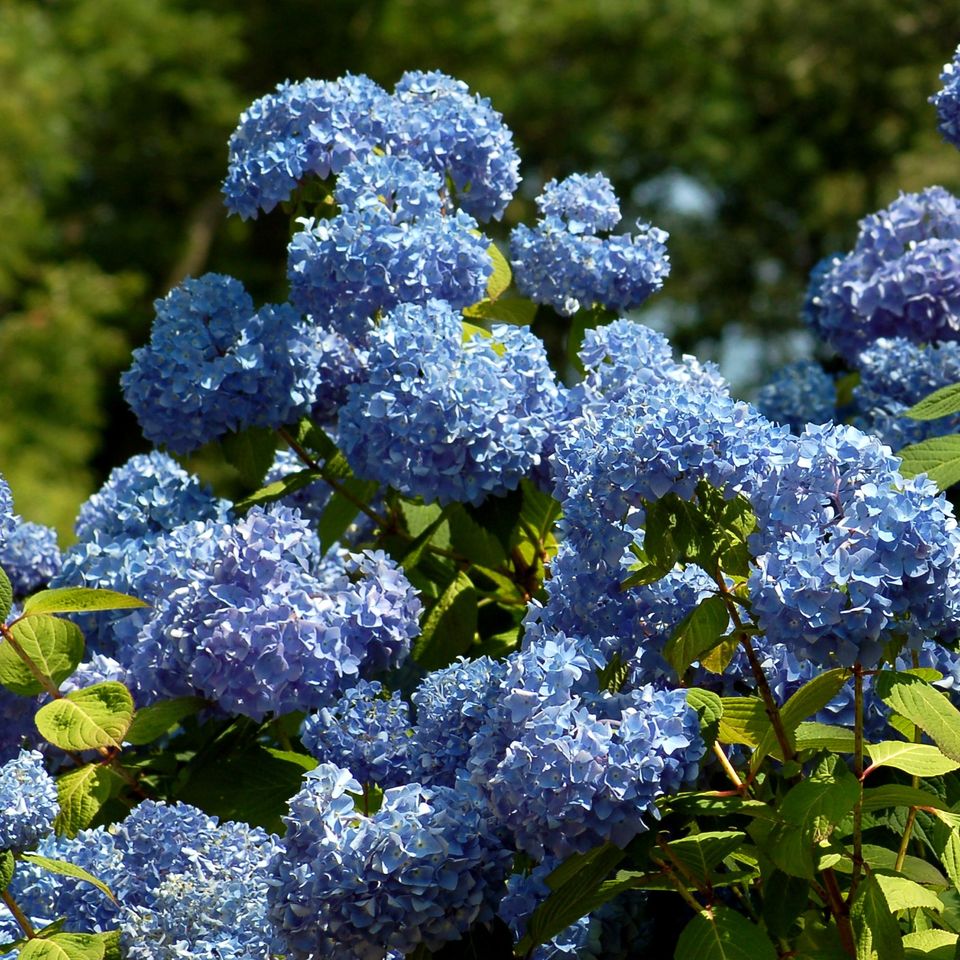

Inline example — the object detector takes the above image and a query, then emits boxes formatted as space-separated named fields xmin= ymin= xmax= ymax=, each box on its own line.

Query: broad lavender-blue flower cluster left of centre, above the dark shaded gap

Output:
xmin=123 ymin=507 xmax=420 ymax=720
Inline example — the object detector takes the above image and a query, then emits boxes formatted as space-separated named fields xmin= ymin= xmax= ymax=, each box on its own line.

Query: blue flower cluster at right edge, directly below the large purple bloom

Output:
xmin=853 ymin=337 xmax=960 ymax=450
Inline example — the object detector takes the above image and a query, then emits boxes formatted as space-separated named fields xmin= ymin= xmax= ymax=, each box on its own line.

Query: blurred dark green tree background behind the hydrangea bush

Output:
xmin=0 ymin=0 xmax=960 ymax=542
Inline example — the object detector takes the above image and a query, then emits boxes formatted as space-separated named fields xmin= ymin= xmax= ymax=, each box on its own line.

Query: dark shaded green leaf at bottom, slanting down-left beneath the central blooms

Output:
xmin=517 ymin=843 xmax=624 ymax=954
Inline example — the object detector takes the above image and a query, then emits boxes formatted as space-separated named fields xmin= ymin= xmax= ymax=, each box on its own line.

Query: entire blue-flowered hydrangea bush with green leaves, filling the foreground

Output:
xmin=0 ymin=54 xmax=960 ymax=960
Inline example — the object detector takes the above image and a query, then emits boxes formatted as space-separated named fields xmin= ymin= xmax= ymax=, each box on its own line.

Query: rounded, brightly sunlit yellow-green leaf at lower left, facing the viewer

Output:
xmin=35 ymin=680 xmax=133 ymax=752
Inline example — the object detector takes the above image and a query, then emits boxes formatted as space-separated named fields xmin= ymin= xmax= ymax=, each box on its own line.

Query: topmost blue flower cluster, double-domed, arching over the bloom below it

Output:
xmin=223 ymin=71 xmax=520 ymax=221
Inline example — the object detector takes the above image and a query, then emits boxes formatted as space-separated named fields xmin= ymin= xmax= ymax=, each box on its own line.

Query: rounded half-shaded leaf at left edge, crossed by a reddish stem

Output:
xmin=0 ymin=616 xmax=84 ymax=697
